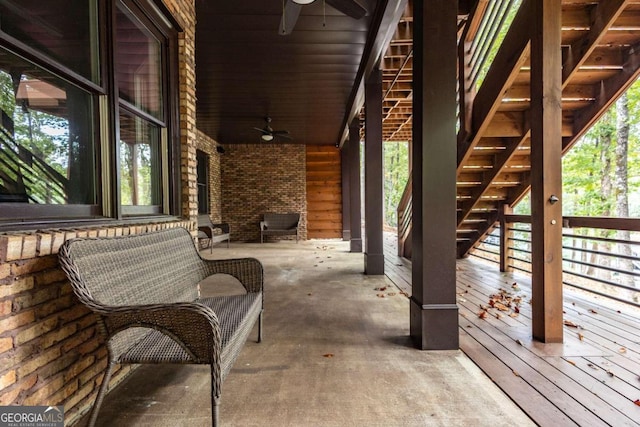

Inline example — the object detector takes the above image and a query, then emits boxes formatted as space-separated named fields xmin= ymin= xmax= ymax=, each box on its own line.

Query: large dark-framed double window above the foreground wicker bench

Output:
xmin=0 ymin=0 xmax=179 ymax=228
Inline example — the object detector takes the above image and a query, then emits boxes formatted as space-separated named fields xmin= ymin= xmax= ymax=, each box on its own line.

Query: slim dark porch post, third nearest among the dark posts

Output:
xmin=347 ymin=118 xmax=362 ymax=253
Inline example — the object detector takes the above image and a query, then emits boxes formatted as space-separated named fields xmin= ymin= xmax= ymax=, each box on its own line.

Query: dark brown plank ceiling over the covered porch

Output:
xmin=196 ymin=0 xmax=386 ymax=145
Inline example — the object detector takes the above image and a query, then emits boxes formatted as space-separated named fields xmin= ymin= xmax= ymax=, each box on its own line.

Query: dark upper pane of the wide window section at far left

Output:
xmin=0 ymin=0 xmax=100 ymax=84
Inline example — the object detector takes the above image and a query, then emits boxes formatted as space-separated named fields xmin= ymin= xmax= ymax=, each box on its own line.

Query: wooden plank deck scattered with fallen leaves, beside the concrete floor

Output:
xmin=385 ymin=234 xmax=640 ymax=426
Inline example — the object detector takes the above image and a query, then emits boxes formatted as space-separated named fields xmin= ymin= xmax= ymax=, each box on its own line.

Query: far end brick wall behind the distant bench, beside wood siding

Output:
xmin=221 ymin=144 xmax=307 ymax=241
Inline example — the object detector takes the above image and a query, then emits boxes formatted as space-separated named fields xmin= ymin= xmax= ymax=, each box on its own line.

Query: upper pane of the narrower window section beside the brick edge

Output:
xmin=116 ymin=7 xmax=163 ymax=120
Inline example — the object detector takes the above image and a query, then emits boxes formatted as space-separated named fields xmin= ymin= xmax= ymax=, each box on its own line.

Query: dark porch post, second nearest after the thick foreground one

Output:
xmin=364 ymin=67 xmax=384 ymax=275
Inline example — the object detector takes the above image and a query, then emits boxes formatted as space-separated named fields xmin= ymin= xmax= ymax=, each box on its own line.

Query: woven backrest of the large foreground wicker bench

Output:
xmin=59 ymin=228 xmax=205 ymax=306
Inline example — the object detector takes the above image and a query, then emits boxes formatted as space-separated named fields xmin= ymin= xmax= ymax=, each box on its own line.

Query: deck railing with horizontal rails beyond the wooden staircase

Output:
xmin=472 ymin=215 xmax=640 ymax=307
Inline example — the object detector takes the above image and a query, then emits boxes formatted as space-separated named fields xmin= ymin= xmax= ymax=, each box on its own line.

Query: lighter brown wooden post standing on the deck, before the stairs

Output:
xmin=529 ymin=0 xmax=563 ymax=342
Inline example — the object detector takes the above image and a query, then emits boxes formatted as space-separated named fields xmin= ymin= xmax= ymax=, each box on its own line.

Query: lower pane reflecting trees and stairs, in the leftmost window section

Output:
xmin=0 ymin=49 xmax=97 ymax=205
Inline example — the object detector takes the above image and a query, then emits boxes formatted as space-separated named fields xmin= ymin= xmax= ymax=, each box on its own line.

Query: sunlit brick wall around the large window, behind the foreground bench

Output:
xmin=0 ymin=0 xmax=198 ymax=426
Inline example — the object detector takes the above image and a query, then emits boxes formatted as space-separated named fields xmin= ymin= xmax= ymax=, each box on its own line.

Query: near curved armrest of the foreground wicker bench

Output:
xmin=96 ymin=302 xmax=222 ymax=367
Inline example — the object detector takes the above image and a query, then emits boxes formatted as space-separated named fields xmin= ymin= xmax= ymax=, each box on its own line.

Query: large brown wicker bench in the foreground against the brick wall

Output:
xmin=59 ymin=228 xmax=263 ymax=426
